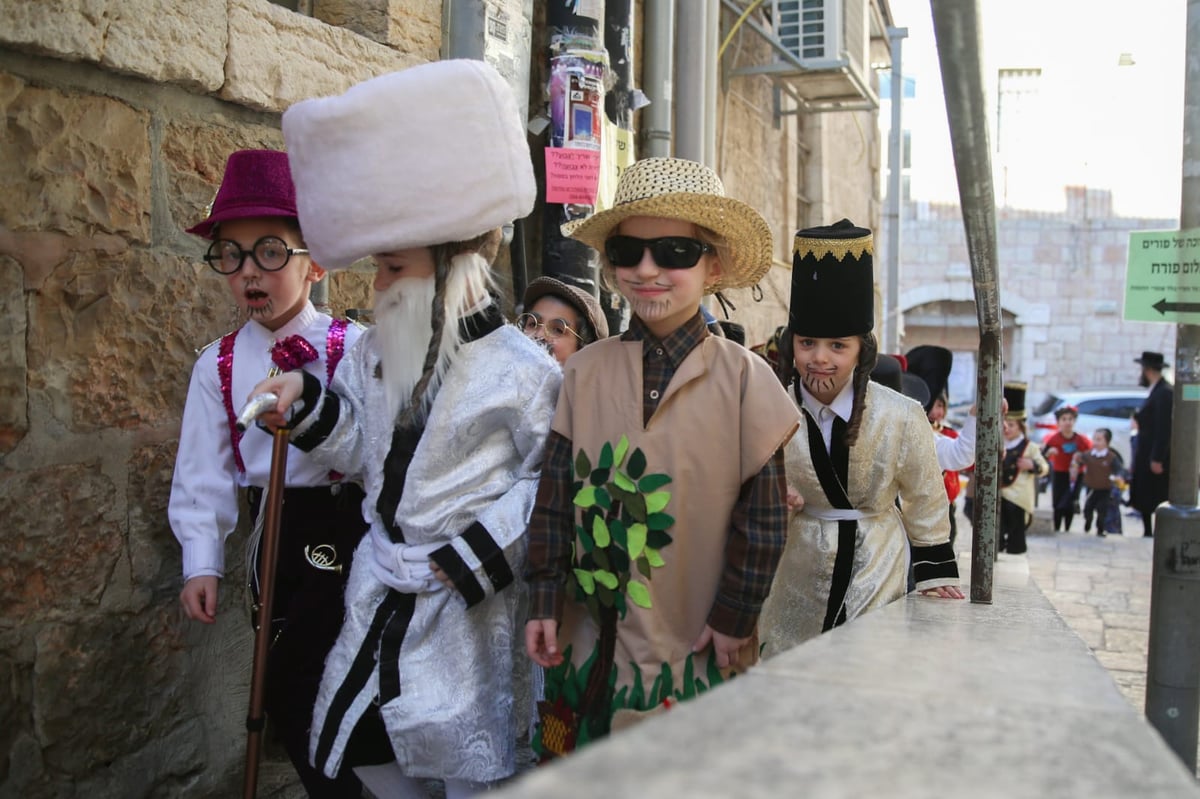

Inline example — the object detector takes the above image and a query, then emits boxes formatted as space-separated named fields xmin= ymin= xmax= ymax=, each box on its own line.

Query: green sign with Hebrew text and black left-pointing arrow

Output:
xmin=1124 ymin=229 xmax=1200 ymax=325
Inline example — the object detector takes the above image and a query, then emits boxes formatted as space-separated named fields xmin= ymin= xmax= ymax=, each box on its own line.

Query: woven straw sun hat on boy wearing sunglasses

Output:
xmin=563 ymin=158 xmax=773 ymax=293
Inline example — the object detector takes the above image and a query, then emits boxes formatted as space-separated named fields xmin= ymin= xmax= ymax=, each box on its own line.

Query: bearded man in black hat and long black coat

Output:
xmin=1129 ymin=353 xmax=1174 ymax=537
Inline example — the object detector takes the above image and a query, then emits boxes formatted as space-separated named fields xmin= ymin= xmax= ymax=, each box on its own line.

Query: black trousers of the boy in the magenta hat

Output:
xmin=246 ymin=483 xmax=367 ymax=799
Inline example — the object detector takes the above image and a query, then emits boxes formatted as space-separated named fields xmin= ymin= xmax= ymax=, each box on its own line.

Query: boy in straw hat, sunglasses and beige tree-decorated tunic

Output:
xmin=526 ymin=153 xmax=797 ymax=758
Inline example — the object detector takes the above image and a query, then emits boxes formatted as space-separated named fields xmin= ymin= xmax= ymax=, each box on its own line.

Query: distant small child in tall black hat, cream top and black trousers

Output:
xmin=996 ymin=383 xmax=1050 ymax=554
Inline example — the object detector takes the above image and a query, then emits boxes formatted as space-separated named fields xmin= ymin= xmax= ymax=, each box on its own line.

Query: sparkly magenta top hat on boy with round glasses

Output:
xmin=187 ymin=150 xmax=299 ymax=239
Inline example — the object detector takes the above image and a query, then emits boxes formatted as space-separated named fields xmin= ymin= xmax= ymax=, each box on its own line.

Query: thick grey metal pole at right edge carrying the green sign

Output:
xmin=1146 ymin=0 xmax=1200 ymax=774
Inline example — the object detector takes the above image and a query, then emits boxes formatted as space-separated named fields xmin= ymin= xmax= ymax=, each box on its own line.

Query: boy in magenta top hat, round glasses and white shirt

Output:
xmin=168 ymin=150 xmax=365 ymax=797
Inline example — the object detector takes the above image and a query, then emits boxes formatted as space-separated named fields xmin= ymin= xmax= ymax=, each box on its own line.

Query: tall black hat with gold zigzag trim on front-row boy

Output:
xmin=787 ymin=220 xmax=875 ymax=338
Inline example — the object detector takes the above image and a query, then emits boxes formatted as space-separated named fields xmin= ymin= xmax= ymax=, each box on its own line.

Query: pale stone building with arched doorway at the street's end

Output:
xmin=880 ymin=187 xmax=1178 ymax=402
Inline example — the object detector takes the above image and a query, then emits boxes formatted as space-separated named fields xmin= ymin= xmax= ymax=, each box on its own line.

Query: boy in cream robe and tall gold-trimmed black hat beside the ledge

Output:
xmin=762 ymin=220 xmax=962 ymax=653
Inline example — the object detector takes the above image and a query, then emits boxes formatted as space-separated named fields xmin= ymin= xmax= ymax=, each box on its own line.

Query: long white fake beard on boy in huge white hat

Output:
xmin=374 ymin=277 xmax=434 ymax=421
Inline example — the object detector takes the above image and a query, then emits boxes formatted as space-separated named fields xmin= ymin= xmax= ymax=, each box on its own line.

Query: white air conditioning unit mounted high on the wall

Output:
xmin=770 ymin=0 xmax=874 ymax=102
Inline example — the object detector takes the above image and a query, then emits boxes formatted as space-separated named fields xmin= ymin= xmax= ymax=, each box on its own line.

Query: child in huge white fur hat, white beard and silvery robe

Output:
xmin=247 ymin=60 xmax=562 ymax=799
